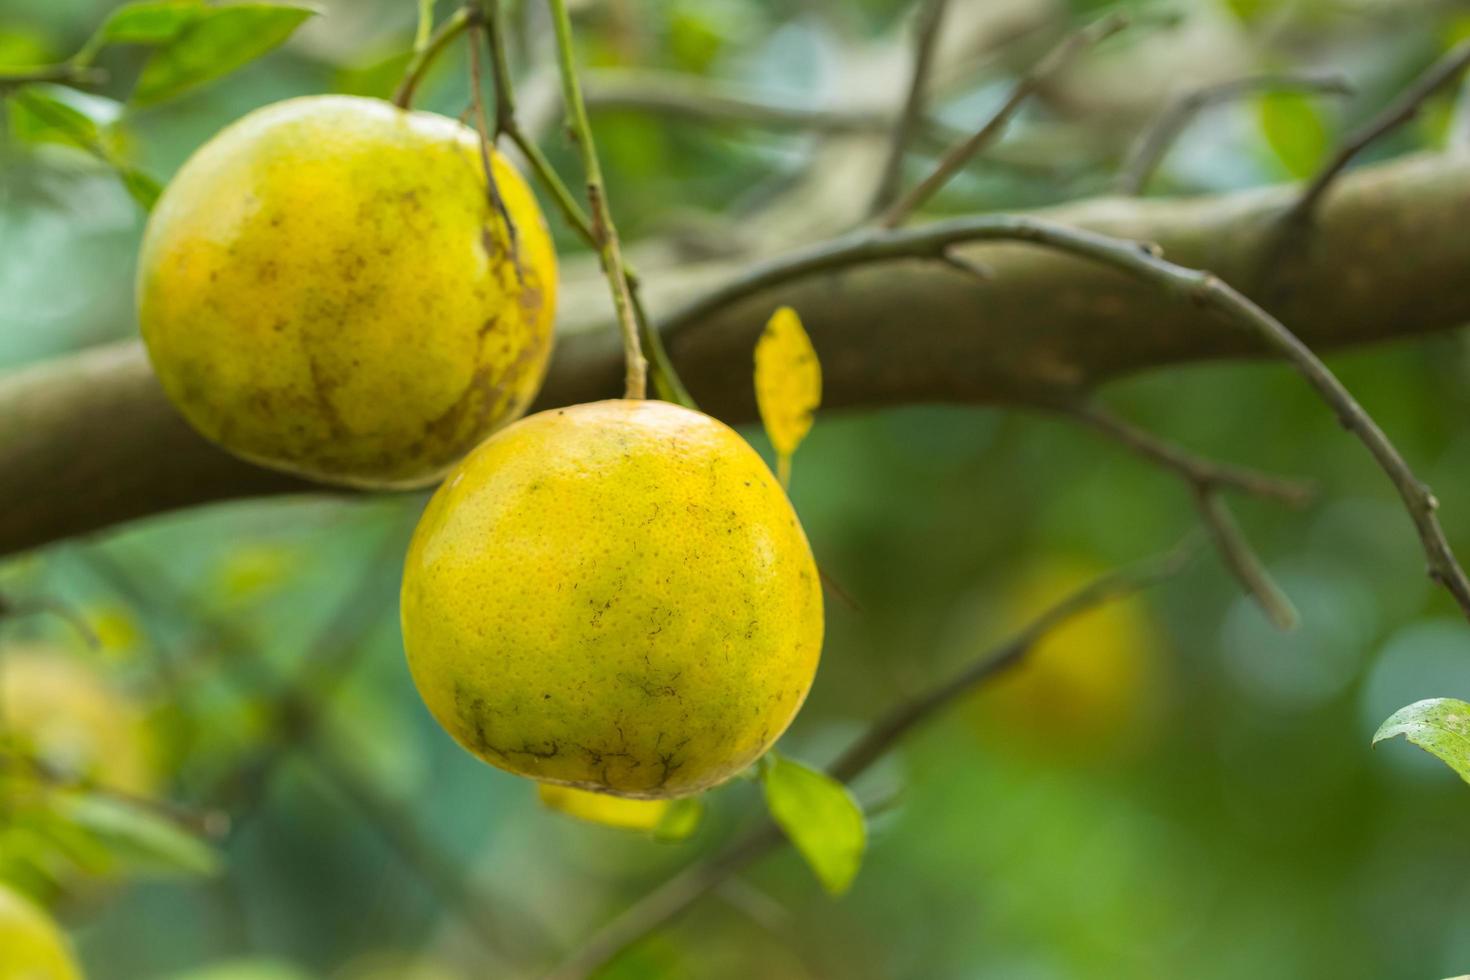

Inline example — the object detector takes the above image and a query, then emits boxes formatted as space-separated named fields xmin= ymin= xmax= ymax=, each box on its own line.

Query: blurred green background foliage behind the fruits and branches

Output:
xmin=0 ymin=0 xmax=1470 ymax=980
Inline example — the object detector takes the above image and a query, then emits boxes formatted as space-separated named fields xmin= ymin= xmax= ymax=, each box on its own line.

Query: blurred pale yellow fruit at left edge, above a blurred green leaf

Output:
xmin=0 ymin=646 xmax=157 ymax=795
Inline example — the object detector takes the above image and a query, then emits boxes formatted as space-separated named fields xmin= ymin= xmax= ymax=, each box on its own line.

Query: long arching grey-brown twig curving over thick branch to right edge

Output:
xmin=663 ymin=215 xmax=1470 ymax=617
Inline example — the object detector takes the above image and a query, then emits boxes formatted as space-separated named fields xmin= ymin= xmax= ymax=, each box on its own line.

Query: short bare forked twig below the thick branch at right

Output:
xmin=1069 ymin=403 xmax=1313 ymax=630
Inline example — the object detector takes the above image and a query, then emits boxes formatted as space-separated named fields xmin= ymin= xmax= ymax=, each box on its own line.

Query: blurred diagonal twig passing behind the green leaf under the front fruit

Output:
xmin=547 ymin=536 xmax=1195 ymax=980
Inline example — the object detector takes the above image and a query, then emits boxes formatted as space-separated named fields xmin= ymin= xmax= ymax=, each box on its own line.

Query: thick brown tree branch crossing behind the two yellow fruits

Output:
xmin=0 ymin=156 xmax=1470 ymax=552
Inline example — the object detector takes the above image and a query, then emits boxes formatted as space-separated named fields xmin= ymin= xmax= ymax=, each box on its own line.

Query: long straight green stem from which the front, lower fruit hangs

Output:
xmin=547 ymin=0 xmax=648 ymax=398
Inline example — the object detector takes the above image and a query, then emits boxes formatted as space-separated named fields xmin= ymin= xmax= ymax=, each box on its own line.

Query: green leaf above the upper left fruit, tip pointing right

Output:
xmin=132 ymin=3 xmax=318 ymax=106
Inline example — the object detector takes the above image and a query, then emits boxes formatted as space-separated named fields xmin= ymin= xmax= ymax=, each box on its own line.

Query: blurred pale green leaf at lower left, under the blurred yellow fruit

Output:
xmin=54 ymin=793 xmax=221 ymax=874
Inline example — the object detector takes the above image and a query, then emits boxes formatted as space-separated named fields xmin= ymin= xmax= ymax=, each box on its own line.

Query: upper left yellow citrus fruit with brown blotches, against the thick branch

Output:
xmin=138 ymin=96 xmax=556 ymax=486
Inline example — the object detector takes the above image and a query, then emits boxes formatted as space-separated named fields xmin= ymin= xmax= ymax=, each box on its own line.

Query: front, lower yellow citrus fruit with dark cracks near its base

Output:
xmin=403 ymin=401 xmax=822 ymax=799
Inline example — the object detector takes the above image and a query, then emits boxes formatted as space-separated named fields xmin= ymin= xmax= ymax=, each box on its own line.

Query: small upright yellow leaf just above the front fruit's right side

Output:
xmin=756 ymin=306 xmax=822 ymax=486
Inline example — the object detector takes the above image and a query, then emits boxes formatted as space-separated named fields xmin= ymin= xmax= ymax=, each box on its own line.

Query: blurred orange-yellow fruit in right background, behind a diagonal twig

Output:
xmin=970 ymin=558 xmax=1163 ymax=760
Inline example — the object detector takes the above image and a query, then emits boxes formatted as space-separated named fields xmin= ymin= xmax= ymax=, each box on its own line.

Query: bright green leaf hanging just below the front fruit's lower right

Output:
xmin=761 ymin=752 xmax=867 ymax=895
